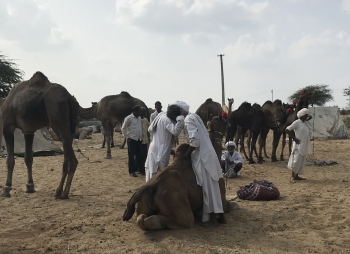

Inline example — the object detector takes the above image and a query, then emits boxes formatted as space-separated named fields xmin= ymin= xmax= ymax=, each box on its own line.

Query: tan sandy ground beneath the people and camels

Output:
xmin=0 ymin=133 xmax=350 ymax=253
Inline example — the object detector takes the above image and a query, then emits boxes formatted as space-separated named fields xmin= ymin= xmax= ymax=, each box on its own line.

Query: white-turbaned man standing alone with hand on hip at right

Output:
xmin=286 ymin=108 xmax=312 ymax=181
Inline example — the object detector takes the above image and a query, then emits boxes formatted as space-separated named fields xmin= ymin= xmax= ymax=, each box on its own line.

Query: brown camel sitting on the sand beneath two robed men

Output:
xmin=123 ymin=144 xmax=227 ymax=230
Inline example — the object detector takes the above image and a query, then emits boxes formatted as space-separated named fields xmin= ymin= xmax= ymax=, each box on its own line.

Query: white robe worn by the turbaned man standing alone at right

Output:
xmin=287 ymin=119 xmax=312 ymax=174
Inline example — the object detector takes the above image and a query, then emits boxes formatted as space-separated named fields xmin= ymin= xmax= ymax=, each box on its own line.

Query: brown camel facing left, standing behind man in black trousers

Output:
xmin=79 ymin=92 xmax=149 ymax=159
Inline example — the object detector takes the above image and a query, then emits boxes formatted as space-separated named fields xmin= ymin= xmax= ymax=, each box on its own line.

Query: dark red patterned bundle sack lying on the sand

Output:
xmin=237 ymin=180 xmax=280 ymax=201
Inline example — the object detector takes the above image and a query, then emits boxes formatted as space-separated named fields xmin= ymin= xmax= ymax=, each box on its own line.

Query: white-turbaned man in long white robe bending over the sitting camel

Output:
xmin=176 ymin=101 xmax=224 ymax=226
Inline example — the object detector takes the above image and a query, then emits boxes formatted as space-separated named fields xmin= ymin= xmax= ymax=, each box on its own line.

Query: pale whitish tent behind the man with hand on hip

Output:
xmin=306 ymin=106 xmax=349 ymax=139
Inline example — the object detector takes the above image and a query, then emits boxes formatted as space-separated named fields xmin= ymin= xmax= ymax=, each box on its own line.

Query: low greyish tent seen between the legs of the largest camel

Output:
xmin=0 ymin=128 xmax=62 ymax=156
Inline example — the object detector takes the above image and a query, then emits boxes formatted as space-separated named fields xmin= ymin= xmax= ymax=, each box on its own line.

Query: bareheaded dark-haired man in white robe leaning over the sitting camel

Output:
xmin=145 ymin=105 xmax=184 ymax=182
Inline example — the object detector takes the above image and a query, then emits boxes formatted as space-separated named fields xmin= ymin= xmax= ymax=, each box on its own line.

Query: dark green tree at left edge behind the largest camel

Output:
xmin=0 ymin=52 xmax=24 ymax=98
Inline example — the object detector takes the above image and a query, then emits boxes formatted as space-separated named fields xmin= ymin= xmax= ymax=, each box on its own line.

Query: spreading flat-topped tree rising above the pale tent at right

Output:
xmin=288 ymin=85 xmax=334 ymax=106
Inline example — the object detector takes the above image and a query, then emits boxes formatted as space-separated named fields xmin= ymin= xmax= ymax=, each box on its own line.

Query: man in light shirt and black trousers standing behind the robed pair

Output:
xmin=122 ymin=105 xmax=145 ymax=177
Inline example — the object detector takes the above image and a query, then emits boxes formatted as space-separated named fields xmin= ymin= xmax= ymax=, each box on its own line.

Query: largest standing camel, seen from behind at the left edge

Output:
xmin=1 ymin=72 xmax=79 ymax=199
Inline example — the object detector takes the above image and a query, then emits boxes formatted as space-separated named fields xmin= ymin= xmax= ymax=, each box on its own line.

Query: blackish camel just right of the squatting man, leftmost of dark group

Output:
xmin=226 ymin=102 xmax=286 ymax=164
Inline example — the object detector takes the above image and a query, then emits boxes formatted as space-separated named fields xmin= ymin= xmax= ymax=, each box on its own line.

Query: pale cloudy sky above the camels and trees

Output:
xmin=0 ymin=0 xmax=350 ymax=112
